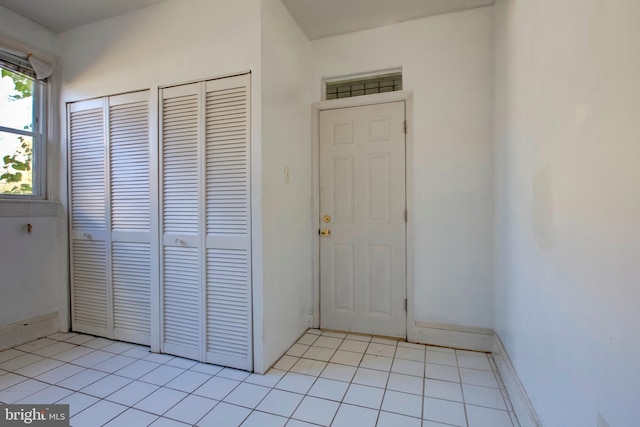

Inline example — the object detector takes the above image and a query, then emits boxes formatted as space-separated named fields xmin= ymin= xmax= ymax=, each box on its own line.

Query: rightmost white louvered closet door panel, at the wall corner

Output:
xmin=205 ymin=75 xmax=253 ymax=370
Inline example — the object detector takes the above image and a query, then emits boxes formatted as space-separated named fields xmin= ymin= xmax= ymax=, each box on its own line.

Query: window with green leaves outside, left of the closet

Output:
xmin=0 ymin=51 xmax=46 ymax=198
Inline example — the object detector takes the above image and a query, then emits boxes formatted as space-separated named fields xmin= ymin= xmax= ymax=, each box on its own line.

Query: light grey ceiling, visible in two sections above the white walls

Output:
xmin=0 ymin=0 xmax=494 ymax=40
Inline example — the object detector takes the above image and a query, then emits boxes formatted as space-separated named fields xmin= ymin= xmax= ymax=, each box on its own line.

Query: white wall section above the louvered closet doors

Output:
xmin=60 ymin=0 xmax=260 ymax=102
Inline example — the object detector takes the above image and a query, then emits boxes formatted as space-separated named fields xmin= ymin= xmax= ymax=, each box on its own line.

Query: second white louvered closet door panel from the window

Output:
xmin=108 ymin=91 xmax=152 ymax=345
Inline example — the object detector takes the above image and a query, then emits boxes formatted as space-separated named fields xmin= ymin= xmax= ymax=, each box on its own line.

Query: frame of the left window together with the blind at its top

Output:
xmin=0 ymin=47 xmax=48 ymax=201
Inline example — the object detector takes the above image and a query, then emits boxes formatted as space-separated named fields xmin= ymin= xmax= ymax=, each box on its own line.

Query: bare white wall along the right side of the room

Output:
xmin=494 ymin=0 xmax=640 ymax=427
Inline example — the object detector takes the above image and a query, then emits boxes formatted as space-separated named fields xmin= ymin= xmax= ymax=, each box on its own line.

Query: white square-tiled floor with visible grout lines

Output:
xmin=0 ymin=329 xmax=519 ymax=427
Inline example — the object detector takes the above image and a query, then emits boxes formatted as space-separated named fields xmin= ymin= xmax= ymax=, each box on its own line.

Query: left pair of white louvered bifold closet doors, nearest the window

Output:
xmin=68 ymin=91 xmax=152 ymax=345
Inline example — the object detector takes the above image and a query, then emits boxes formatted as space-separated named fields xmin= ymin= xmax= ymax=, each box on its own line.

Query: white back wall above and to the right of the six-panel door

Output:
xmin=311 ymin=7 xmax=493 ymax=328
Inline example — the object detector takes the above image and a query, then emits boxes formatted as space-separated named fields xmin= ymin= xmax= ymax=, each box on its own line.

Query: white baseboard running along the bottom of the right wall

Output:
xmin=493 ymin=334 xmax=542 ymax=427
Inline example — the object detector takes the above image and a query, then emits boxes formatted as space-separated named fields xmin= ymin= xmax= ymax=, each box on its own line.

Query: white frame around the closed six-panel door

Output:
xmin=311 ymin=90 xmax=415 ymax=341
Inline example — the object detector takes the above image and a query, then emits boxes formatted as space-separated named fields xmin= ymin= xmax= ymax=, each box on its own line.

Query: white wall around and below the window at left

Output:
xmin=0 ymin=7 xmax=67 ymax=345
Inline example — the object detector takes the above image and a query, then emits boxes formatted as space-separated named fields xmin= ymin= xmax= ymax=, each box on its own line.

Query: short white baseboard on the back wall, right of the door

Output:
xmin=409 ymin=322 xmax=494 ymax=352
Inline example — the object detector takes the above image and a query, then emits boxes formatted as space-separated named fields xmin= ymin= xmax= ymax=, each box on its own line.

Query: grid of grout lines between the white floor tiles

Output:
xmin=0 ymin=331 xmax=515 ymax=427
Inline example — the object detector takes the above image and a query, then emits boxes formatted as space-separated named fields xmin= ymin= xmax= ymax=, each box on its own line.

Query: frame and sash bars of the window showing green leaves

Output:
xmin=0 ymin=67 xmax=47 ymax=201
